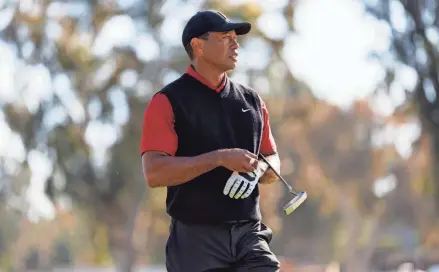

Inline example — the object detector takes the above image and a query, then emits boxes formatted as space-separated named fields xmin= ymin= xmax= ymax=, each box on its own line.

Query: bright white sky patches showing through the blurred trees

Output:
xmin=0 ymin=0 xmax=426 ymax=218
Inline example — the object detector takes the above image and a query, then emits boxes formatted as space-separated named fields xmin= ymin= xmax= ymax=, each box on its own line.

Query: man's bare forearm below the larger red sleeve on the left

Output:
xmin=142 ymin=151 xmax=221 ymax=188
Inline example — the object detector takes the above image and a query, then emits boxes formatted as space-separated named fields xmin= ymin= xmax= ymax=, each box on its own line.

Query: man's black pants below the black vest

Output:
xmin=166 ymin=219 xmax=280 ymax=272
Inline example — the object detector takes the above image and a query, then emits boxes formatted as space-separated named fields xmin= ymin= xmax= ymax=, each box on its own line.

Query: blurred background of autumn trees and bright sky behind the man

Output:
xmin=0 ymin=0 xmax=439 ymax=272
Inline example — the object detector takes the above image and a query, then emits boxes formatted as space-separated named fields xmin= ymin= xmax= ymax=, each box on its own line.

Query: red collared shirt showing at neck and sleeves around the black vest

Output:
xmin=140 ymin=66 xmax=277 ymax=156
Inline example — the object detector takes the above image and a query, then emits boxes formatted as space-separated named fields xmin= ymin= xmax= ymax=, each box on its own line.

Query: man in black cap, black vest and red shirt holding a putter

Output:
xmin=141 ymin=10 xmax=280 ymax=272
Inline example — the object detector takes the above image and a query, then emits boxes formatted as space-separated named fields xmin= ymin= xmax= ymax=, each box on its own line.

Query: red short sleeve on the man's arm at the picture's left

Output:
xmin=140 ymin=94 xmax=178 ymax=156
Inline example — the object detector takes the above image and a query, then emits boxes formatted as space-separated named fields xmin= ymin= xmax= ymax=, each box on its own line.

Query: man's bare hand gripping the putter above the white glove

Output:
xmin=218 ymin=148 xmax=258 ymax=173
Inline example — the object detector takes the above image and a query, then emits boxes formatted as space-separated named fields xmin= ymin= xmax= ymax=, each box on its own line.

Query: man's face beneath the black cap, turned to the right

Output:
xmin=199 ymin=30 xmax=239 ymax=71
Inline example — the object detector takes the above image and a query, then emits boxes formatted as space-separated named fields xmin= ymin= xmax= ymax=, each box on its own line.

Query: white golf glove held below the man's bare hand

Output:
xmin=223 ymin=158 xmax=262 ymax=199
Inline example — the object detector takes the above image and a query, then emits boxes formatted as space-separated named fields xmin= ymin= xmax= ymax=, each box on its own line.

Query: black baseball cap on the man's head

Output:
xmin=182 ymin=10 xmax=251 ymax=47
